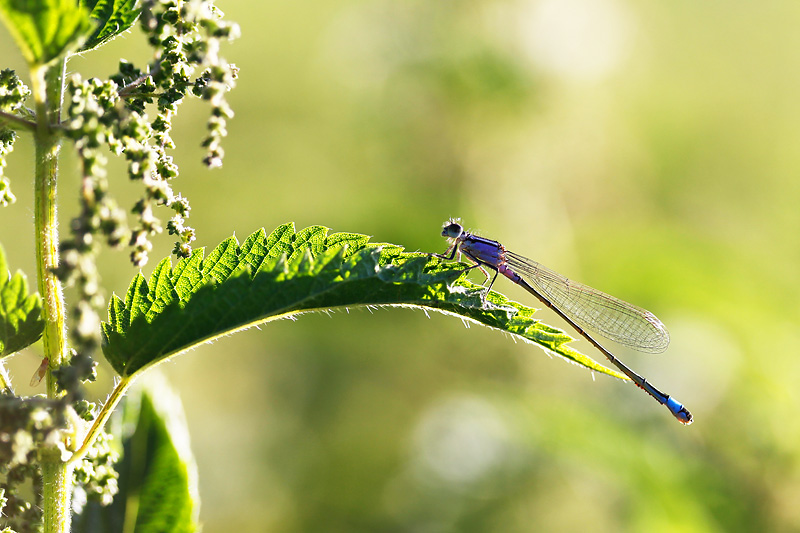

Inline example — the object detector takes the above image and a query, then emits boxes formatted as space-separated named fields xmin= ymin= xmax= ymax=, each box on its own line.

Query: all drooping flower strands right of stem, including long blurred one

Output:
xmin=57 ymin=0 xmax=239 ymax=388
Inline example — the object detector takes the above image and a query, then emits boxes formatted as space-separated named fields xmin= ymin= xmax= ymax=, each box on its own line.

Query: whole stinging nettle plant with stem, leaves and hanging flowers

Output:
xmin=0 ymin=0 xmax=627 ymax=533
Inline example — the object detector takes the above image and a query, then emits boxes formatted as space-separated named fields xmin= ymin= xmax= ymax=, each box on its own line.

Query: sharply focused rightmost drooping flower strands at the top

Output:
xmin=118 ymin=0 xmax=239 ymax=263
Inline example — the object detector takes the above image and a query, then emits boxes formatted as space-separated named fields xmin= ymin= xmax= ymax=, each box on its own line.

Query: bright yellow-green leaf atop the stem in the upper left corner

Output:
xmin=0 ymin=0 xmax=92 ymax=65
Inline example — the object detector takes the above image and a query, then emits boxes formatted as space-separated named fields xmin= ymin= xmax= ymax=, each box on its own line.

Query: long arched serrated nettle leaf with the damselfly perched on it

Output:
xmin=103 ymin=223 xmax=627 ymax=380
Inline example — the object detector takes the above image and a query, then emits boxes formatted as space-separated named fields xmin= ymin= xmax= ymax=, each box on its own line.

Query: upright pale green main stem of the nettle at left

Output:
xmin=32 ymin=60 xmax=72 ymax=533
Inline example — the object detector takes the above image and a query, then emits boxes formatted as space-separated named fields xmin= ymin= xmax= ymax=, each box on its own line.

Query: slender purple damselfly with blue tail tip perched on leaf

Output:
xmin=434 ymin=220 xmax=692 ymax=424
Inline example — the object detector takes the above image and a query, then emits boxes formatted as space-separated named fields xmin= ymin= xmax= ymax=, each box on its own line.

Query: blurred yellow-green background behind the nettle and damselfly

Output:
xmin=0 ymin=0 xmax=800 ymax=533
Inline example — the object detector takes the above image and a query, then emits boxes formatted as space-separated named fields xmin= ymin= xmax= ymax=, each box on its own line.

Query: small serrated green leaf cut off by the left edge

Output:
xmin=0 ymin=246 xmax=44 ymax=357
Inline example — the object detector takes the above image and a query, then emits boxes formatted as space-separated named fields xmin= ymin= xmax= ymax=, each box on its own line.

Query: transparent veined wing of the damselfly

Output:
xmin=505 ymin=252 xmax=669 ymax=353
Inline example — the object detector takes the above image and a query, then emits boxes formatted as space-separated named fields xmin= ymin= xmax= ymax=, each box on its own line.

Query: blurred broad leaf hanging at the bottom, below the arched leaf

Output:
xmin=72 ymin=375 xmax=200 ymax=533
